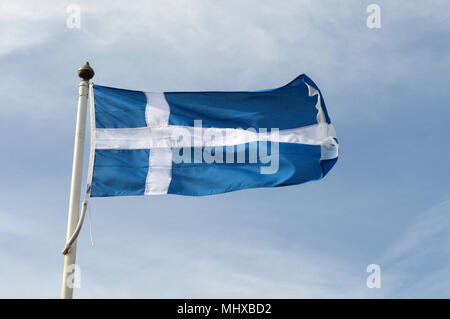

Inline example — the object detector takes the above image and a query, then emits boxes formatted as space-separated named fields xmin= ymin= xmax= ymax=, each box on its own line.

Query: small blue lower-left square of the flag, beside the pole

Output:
xmin=91 ymin=150 xmax=150 ymax=197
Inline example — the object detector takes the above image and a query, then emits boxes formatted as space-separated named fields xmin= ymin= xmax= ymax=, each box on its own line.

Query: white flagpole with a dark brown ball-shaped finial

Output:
xmin=61 ymin=62 xmax=95 ymax=299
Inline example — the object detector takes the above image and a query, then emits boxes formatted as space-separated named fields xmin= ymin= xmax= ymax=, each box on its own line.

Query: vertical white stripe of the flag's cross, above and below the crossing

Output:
xmin=145 ymin=93 xmax=172 ymax=195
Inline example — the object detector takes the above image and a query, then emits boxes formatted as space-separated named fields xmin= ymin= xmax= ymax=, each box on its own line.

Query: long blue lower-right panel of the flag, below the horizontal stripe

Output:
xmin=169 ymin=143 xmax=335 ymax=196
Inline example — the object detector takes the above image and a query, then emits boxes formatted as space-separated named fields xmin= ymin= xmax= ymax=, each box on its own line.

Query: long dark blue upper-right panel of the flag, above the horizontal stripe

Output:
xmin=165 ymin=74 xmax=330 ymax=130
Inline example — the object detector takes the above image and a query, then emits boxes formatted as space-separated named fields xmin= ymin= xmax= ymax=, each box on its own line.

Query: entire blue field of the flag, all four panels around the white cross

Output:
xmin=91 ymin=75 xmax=337 ymax=197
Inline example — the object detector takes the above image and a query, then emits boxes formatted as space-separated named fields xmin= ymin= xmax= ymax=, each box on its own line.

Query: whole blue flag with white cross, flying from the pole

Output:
xmin=88 ymin=74 xmax=338 ymax=197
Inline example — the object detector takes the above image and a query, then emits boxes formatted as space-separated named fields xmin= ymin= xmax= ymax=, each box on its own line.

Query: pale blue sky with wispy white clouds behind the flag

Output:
xmin=0 ymin=0 xmax=450 ymax=298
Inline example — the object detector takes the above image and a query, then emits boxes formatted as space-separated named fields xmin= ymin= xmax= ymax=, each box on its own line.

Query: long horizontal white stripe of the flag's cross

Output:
xmin=95 ymin=124 xmax=336 ymax=150
